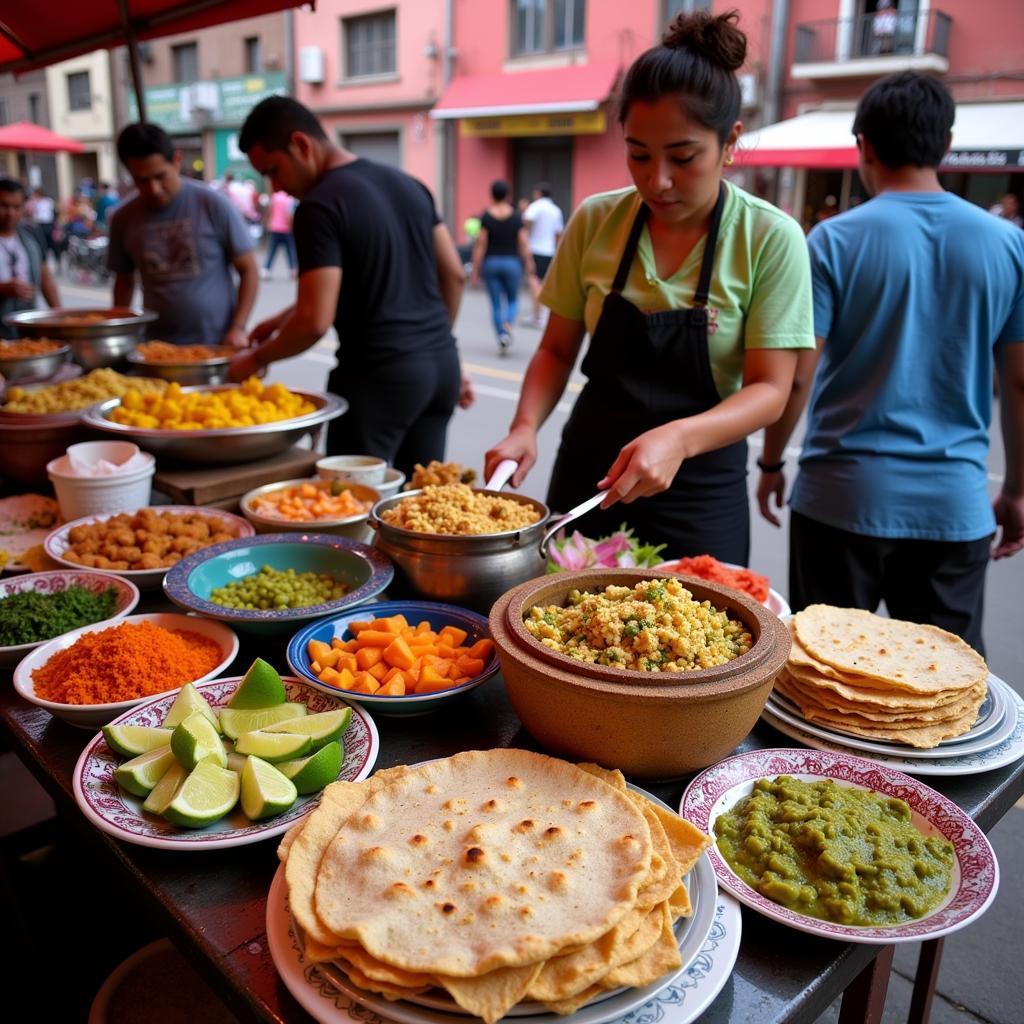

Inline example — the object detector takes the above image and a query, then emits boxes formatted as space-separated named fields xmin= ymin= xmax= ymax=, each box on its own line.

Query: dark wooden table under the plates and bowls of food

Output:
xmin=0 ymin=637 xmax=1024 ymax=1024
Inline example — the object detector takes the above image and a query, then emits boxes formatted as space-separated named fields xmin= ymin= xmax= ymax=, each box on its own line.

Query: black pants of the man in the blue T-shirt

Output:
xmin=790 ymin=511 xmax=992 ymax=654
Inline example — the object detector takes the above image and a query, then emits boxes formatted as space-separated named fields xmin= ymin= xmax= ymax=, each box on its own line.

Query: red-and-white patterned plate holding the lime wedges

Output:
xmin=73 ymin=676 xmax=380 ymax=850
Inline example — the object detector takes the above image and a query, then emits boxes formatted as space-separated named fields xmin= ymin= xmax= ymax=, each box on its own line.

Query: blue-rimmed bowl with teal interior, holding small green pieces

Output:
xmin=164 ymin=534 xmax=394 ymax=635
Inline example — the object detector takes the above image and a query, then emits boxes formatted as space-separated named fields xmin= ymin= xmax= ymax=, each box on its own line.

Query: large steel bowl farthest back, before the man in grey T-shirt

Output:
xmin=3 ymin=306 xmax=157 ymax=370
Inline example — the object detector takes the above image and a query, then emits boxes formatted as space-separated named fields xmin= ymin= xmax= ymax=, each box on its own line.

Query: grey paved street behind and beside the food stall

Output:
xmin=59 ymin=267 xmax=1024 ymax=1024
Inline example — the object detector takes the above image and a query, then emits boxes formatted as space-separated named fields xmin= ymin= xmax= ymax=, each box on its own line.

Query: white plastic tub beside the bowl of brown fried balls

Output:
xmin=46 ymin=441 xmax=157 ymax=521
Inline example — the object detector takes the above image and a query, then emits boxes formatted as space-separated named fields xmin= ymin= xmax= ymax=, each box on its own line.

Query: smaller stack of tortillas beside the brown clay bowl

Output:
xmin=775 ymin=604 xmax=988 ymax=749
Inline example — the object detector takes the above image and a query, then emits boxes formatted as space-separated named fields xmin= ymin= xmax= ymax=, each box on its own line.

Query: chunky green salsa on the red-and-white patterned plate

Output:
xmin=715 ymin=775 xmax=955 ymax=926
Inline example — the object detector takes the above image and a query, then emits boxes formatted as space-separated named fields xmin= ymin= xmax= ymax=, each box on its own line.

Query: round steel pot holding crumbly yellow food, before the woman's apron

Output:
xmin=370 ymin=488 xmax=549 ymax=614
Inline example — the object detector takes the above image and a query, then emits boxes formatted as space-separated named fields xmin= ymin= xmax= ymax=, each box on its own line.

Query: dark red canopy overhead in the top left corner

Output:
xmin=0 ymin=0 xmax=307 ymax=72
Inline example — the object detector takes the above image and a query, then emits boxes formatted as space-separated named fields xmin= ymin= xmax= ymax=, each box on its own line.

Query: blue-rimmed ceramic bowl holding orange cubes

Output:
xmin=288 ymin=601 xmax=499 ymax=717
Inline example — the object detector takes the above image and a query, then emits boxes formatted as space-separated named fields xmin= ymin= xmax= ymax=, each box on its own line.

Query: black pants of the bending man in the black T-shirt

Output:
xmin=327 ymin=348 xmax=460 ymax=476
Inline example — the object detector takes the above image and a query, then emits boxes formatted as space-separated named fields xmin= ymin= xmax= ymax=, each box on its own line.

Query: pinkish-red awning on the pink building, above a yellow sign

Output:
xmin=430 ymin=65 xmax=618 ymax=119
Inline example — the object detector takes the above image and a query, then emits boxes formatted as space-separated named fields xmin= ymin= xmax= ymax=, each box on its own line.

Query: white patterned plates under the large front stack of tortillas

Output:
xmin=266 ymin=867 xmax=742 ymax=1024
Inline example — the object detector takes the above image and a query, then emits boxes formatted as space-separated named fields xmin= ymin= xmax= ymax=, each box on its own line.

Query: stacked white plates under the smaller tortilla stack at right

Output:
xmin=765 ymin=676 xmax=1015 ymax=760
